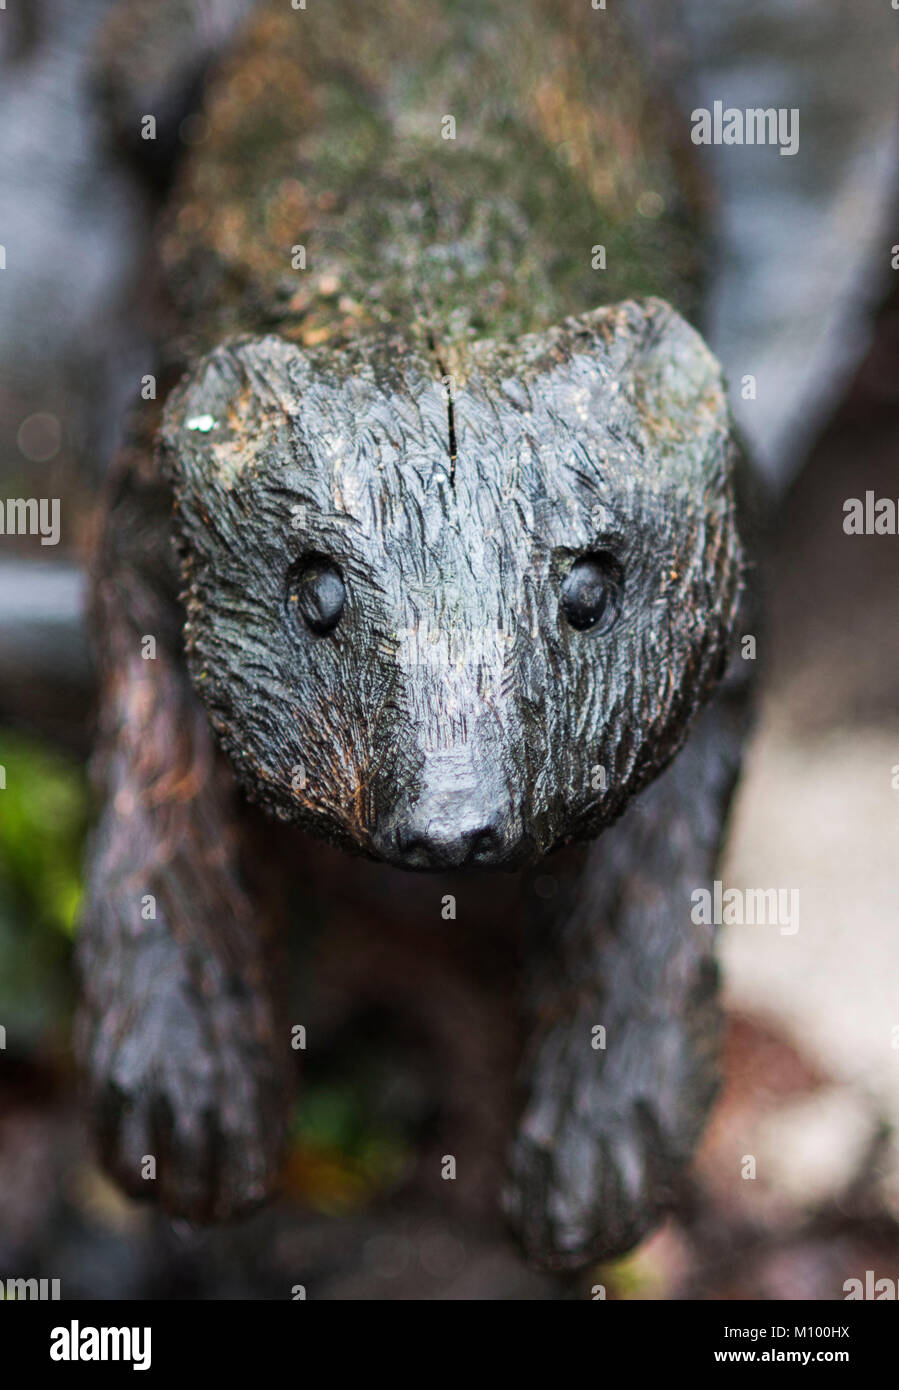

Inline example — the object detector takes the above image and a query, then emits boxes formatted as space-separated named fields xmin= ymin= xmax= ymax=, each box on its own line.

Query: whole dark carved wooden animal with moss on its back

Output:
xmin=78 ymin=0 xmax=749 ymax=1268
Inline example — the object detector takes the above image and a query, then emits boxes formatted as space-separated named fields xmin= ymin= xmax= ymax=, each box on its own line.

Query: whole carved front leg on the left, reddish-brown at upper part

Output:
xmin=76 ymin=461 xmax=290 ymax=1220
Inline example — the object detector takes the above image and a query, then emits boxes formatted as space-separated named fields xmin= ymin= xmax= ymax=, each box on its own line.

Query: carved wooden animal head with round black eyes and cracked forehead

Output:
xmin=163 ymin=300 xmax=742 ymax=869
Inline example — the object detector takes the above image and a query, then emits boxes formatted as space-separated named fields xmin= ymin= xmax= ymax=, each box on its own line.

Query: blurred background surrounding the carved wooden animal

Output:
xmin=0 ymin=0 xmax=899 ymax=1300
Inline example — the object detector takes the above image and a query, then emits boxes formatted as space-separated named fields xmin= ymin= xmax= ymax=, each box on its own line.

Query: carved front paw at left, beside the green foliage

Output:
xmin=79 ymin=929 xmax=285 ymax=1222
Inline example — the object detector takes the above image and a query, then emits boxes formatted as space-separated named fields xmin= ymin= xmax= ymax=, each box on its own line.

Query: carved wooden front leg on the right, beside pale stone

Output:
xmin=506 ymin=678 xmax=743 ymax=1269
